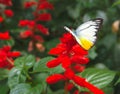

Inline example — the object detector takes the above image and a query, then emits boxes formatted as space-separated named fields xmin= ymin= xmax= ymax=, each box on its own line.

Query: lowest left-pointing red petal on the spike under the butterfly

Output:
xmin=46 ymin=74 xmax=65 ymax=84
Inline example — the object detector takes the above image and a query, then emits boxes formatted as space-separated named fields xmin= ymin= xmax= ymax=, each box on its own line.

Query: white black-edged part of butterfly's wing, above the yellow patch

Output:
xmin=75 ymin=18 xmax=103 ymax=43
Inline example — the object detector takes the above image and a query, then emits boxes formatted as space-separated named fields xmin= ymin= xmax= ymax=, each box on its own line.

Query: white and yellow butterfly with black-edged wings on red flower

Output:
xmin=64 ymin=18 xmax=103 ymax=50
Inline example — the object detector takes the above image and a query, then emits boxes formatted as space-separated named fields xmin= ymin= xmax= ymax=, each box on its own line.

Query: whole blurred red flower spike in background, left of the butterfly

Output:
xmin=18 ymin=0 xmax=53 ymax=51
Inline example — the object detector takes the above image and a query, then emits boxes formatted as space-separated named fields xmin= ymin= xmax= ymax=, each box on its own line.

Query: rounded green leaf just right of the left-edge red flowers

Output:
xmin=14 ymin=55 xmax=35 ymax=70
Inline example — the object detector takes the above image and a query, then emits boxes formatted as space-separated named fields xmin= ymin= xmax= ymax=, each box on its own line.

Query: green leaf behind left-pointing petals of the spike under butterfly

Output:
xmin=33 ymin=57 xmax=63 ymax=73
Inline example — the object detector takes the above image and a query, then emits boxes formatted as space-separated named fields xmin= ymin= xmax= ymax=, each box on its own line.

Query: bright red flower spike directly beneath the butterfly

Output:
xmin=46 ymin=33 xmax=104 ymax=94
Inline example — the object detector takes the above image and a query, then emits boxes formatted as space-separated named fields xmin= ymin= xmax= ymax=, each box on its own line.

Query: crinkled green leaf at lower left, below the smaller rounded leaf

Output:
xmin=8 ymin=67 xmax=26 ymax=88
